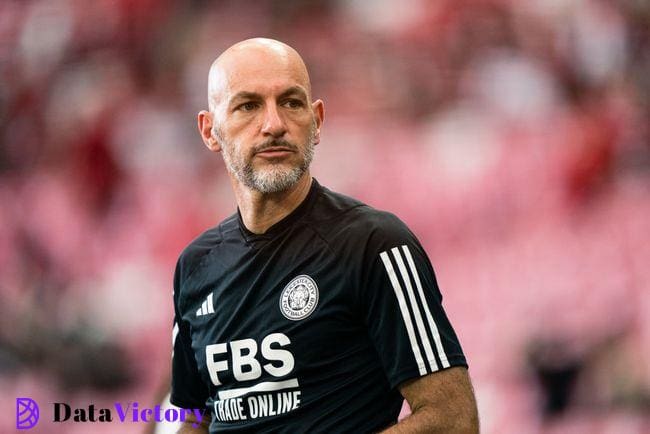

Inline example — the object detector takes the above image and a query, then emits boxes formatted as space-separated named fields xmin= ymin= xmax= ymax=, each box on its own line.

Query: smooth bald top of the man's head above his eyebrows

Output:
xmin=208 ymin=38 xmax=311 ymax=112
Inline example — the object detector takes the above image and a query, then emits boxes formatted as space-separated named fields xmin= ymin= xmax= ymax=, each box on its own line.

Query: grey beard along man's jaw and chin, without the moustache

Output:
xmin=213 ymin=125 xmax=316 ymax=194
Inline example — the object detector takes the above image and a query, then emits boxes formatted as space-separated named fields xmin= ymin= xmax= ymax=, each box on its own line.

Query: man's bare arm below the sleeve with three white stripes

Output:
xmin=384 ymin=367 xmax=479 ymax=434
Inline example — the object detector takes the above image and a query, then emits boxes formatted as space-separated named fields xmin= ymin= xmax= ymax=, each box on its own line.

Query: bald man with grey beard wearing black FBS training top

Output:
xmin=171 ymin=38 xmax=478 ymax=434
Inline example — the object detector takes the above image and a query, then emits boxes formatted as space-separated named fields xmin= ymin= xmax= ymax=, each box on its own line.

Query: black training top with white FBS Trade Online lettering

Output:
xmin=171 ymin=179 xmax=467 ymax=433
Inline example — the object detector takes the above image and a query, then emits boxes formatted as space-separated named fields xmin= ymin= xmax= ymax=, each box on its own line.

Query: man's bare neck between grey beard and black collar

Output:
xmin=231 ymin=172 xmax=312 ymax=234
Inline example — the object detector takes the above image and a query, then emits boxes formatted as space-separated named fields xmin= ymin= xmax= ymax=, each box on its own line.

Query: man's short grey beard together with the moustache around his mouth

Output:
xmin=213 ymin=123 xmax=316 ymax=194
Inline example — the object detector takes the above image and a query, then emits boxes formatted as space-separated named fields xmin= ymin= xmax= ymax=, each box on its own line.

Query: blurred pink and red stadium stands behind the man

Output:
xmin=0 ymin=0 xmax=650 ymax=434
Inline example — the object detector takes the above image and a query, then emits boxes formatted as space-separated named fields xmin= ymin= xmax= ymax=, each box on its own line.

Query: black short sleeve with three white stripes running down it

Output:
xmin=359 ymin=214 xmax=467 ymax=387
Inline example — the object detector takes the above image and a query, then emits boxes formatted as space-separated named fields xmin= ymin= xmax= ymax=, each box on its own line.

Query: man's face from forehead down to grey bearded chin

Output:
xmin=212 ymin=48 xmax=319 ymax=193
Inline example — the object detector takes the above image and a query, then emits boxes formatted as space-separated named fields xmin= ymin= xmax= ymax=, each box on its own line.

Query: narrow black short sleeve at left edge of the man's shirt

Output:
xmin=170 ymin=262 xmax=208 ymax=408
